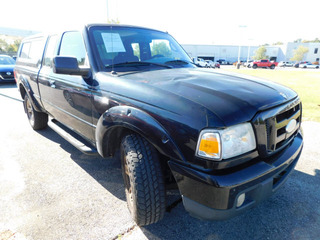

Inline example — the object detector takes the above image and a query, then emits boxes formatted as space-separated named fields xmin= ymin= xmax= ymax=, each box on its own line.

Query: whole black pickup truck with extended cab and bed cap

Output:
xmin=14 ymin=24 xmax=303 ymax=225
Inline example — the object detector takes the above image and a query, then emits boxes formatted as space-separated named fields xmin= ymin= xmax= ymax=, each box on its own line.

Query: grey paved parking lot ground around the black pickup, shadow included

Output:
xmin=0 ymin=83 xmax=320 ymax=240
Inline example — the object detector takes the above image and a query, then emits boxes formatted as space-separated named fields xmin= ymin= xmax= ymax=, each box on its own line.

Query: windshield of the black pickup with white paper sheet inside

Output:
xmin=89 ymin=26 xmax=194 ymax=72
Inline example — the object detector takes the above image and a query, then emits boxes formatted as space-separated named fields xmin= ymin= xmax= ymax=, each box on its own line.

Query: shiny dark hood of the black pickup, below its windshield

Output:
xmin=102 ymin=68 xmax=297 ymax=126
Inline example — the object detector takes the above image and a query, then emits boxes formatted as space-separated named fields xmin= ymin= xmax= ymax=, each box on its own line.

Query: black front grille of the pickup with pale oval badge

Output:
xmin=253 ymin=99 xmax=302 ymax=157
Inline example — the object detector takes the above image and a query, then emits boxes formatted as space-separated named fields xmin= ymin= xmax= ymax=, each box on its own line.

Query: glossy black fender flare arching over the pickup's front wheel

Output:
xmin=96 ymin=106 xmax=185 ymax=161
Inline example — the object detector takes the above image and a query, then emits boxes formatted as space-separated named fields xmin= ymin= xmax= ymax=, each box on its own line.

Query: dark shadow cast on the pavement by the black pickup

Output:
xmin=38 ymin=128 xmax=320 ymax=240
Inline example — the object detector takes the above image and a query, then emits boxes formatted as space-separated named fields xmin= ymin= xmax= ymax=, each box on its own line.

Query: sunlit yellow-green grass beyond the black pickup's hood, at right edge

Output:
xmin=225 ymin=68 xmax=320 ymax=122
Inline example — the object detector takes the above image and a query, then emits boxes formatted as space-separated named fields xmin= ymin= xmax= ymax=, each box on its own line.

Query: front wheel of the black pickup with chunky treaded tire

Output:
xmin=121 ymin=134 xmax=166 ymax=226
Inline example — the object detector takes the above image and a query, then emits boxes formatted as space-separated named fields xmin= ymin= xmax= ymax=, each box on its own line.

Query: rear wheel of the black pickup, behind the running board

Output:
xmin=23 ymin=94 xmax=48 ymax=130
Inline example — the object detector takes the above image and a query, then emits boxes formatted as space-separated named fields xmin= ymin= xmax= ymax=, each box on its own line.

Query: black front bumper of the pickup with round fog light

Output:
xmin=169 ymin=132 xmax=303 ymax=220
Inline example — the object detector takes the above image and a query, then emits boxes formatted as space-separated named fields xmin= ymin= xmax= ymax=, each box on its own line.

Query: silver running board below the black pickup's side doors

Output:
xmin=48 ymin=118 xmax=99 ymax=155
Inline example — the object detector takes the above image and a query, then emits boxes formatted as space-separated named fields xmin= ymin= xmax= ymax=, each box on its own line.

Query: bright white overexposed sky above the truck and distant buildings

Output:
xmin=0 ymin=0 xmax=320 ymax=45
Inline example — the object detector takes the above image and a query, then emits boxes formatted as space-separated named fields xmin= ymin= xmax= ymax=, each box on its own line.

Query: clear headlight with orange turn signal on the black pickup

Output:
xmin=196 ymin=123 xmax=256 ymax=161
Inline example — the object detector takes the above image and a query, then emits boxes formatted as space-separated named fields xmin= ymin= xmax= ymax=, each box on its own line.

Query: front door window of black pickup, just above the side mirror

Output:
xmin=59 ymin=32 xmax=88 ymax=66
